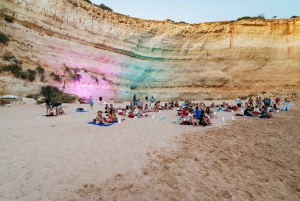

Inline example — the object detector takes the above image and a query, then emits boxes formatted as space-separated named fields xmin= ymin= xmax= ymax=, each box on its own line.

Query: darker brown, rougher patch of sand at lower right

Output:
xmin=71 ymin=110 xmax=300 ymax=201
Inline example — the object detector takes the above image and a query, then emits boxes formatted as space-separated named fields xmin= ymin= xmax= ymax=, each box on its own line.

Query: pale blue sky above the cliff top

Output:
xmin=91 ymin=0 xmax=300 ymax=23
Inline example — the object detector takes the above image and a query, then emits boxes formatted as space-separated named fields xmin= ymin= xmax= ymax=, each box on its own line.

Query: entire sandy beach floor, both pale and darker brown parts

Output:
xmin=0 ymin=101 xmax=300 ymax=201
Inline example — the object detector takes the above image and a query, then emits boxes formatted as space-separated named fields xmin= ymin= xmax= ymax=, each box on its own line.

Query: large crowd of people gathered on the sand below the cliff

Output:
xmin=86 ymin=94 xmax=289 ymax=126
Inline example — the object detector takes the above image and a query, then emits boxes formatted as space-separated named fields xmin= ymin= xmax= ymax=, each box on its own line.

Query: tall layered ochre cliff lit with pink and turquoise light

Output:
xmin=0 ymin=0 xmax=300 ymax=101
